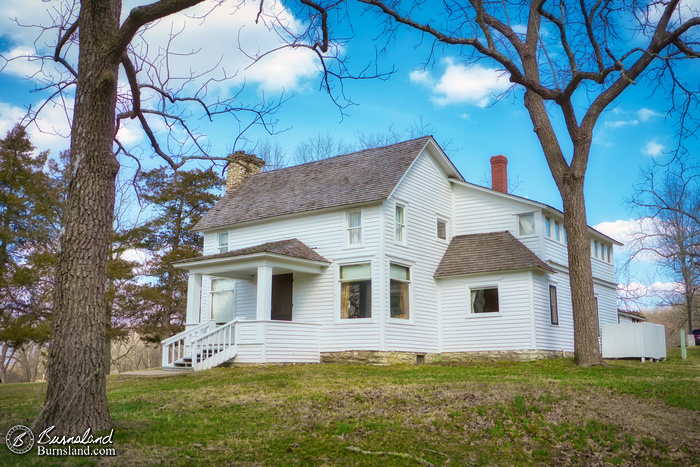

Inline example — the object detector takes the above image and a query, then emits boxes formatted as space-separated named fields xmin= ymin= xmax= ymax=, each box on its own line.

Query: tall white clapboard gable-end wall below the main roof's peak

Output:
xmin=382 ymin=153 xmax=452 ymax=352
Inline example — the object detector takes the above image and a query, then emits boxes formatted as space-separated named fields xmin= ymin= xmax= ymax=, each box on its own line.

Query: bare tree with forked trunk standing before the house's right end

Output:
xmin=280 ymin=0 xmax=700 ymax=366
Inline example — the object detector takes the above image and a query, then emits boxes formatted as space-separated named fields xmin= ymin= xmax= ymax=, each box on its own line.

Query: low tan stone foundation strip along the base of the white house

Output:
xmin=321 ymin=350 xmax=574 ymax=365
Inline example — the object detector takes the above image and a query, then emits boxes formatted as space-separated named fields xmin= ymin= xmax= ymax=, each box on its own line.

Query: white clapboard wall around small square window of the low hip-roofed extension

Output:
xmin=439 ymin=272 xmax=531 ymax=352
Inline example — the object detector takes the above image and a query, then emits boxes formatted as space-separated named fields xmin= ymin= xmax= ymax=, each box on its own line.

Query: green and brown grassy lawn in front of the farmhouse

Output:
xmin=0 ymin=348 xmax=700 ymax=466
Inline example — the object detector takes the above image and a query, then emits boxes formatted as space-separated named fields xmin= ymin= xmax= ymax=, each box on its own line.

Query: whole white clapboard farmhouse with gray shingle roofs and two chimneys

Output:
xmin=163 ymin=137 xmax=620 ymax=369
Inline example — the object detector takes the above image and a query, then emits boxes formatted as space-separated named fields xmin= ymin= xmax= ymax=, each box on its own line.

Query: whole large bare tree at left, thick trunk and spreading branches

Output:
xmin=0 ymin=0 xmax=292 ymax=436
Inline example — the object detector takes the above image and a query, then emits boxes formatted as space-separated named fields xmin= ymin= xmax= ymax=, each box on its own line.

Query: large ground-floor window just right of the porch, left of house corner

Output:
xmin=340 ymin=263 xmax=372 ymax=319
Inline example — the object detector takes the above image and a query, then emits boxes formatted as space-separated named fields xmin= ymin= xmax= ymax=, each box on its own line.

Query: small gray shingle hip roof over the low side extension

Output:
xmin=435 ymin=232 xmax=555 ymax=277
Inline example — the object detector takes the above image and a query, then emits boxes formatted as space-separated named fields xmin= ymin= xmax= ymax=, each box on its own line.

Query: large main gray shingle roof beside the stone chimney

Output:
xmin=194 ymin=136 xmax=432 ymax=230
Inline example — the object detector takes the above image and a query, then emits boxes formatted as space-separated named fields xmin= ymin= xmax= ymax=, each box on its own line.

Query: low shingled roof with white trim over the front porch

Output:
xmin=173 ymin=238 xmax=330 ymax=279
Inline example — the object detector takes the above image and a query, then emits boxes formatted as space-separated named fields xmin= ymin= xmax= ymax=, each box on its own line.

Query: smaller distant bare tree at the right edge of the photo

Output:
xmin=628 ymin=154 xmax=700 ymax=332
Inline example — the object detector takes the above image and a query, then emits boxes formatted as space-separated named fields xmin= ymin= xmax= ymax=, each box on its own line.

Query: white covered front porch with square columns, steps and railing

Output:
xmin=163 ymin=239 xmax=330 ymax=370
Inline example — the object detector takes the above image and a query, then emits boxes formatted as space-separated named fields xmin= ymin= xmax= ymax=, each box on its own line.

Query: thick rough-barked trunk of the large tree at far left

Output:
xmin=40 ymin=0 xmax=121 ymax=436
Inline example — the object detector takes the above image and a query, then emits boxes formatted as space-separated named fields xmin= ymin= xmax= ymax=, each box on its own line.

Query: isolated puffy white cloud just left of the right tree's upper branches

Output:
xmin=409 ymin=58 xmax=511 ymax=107
